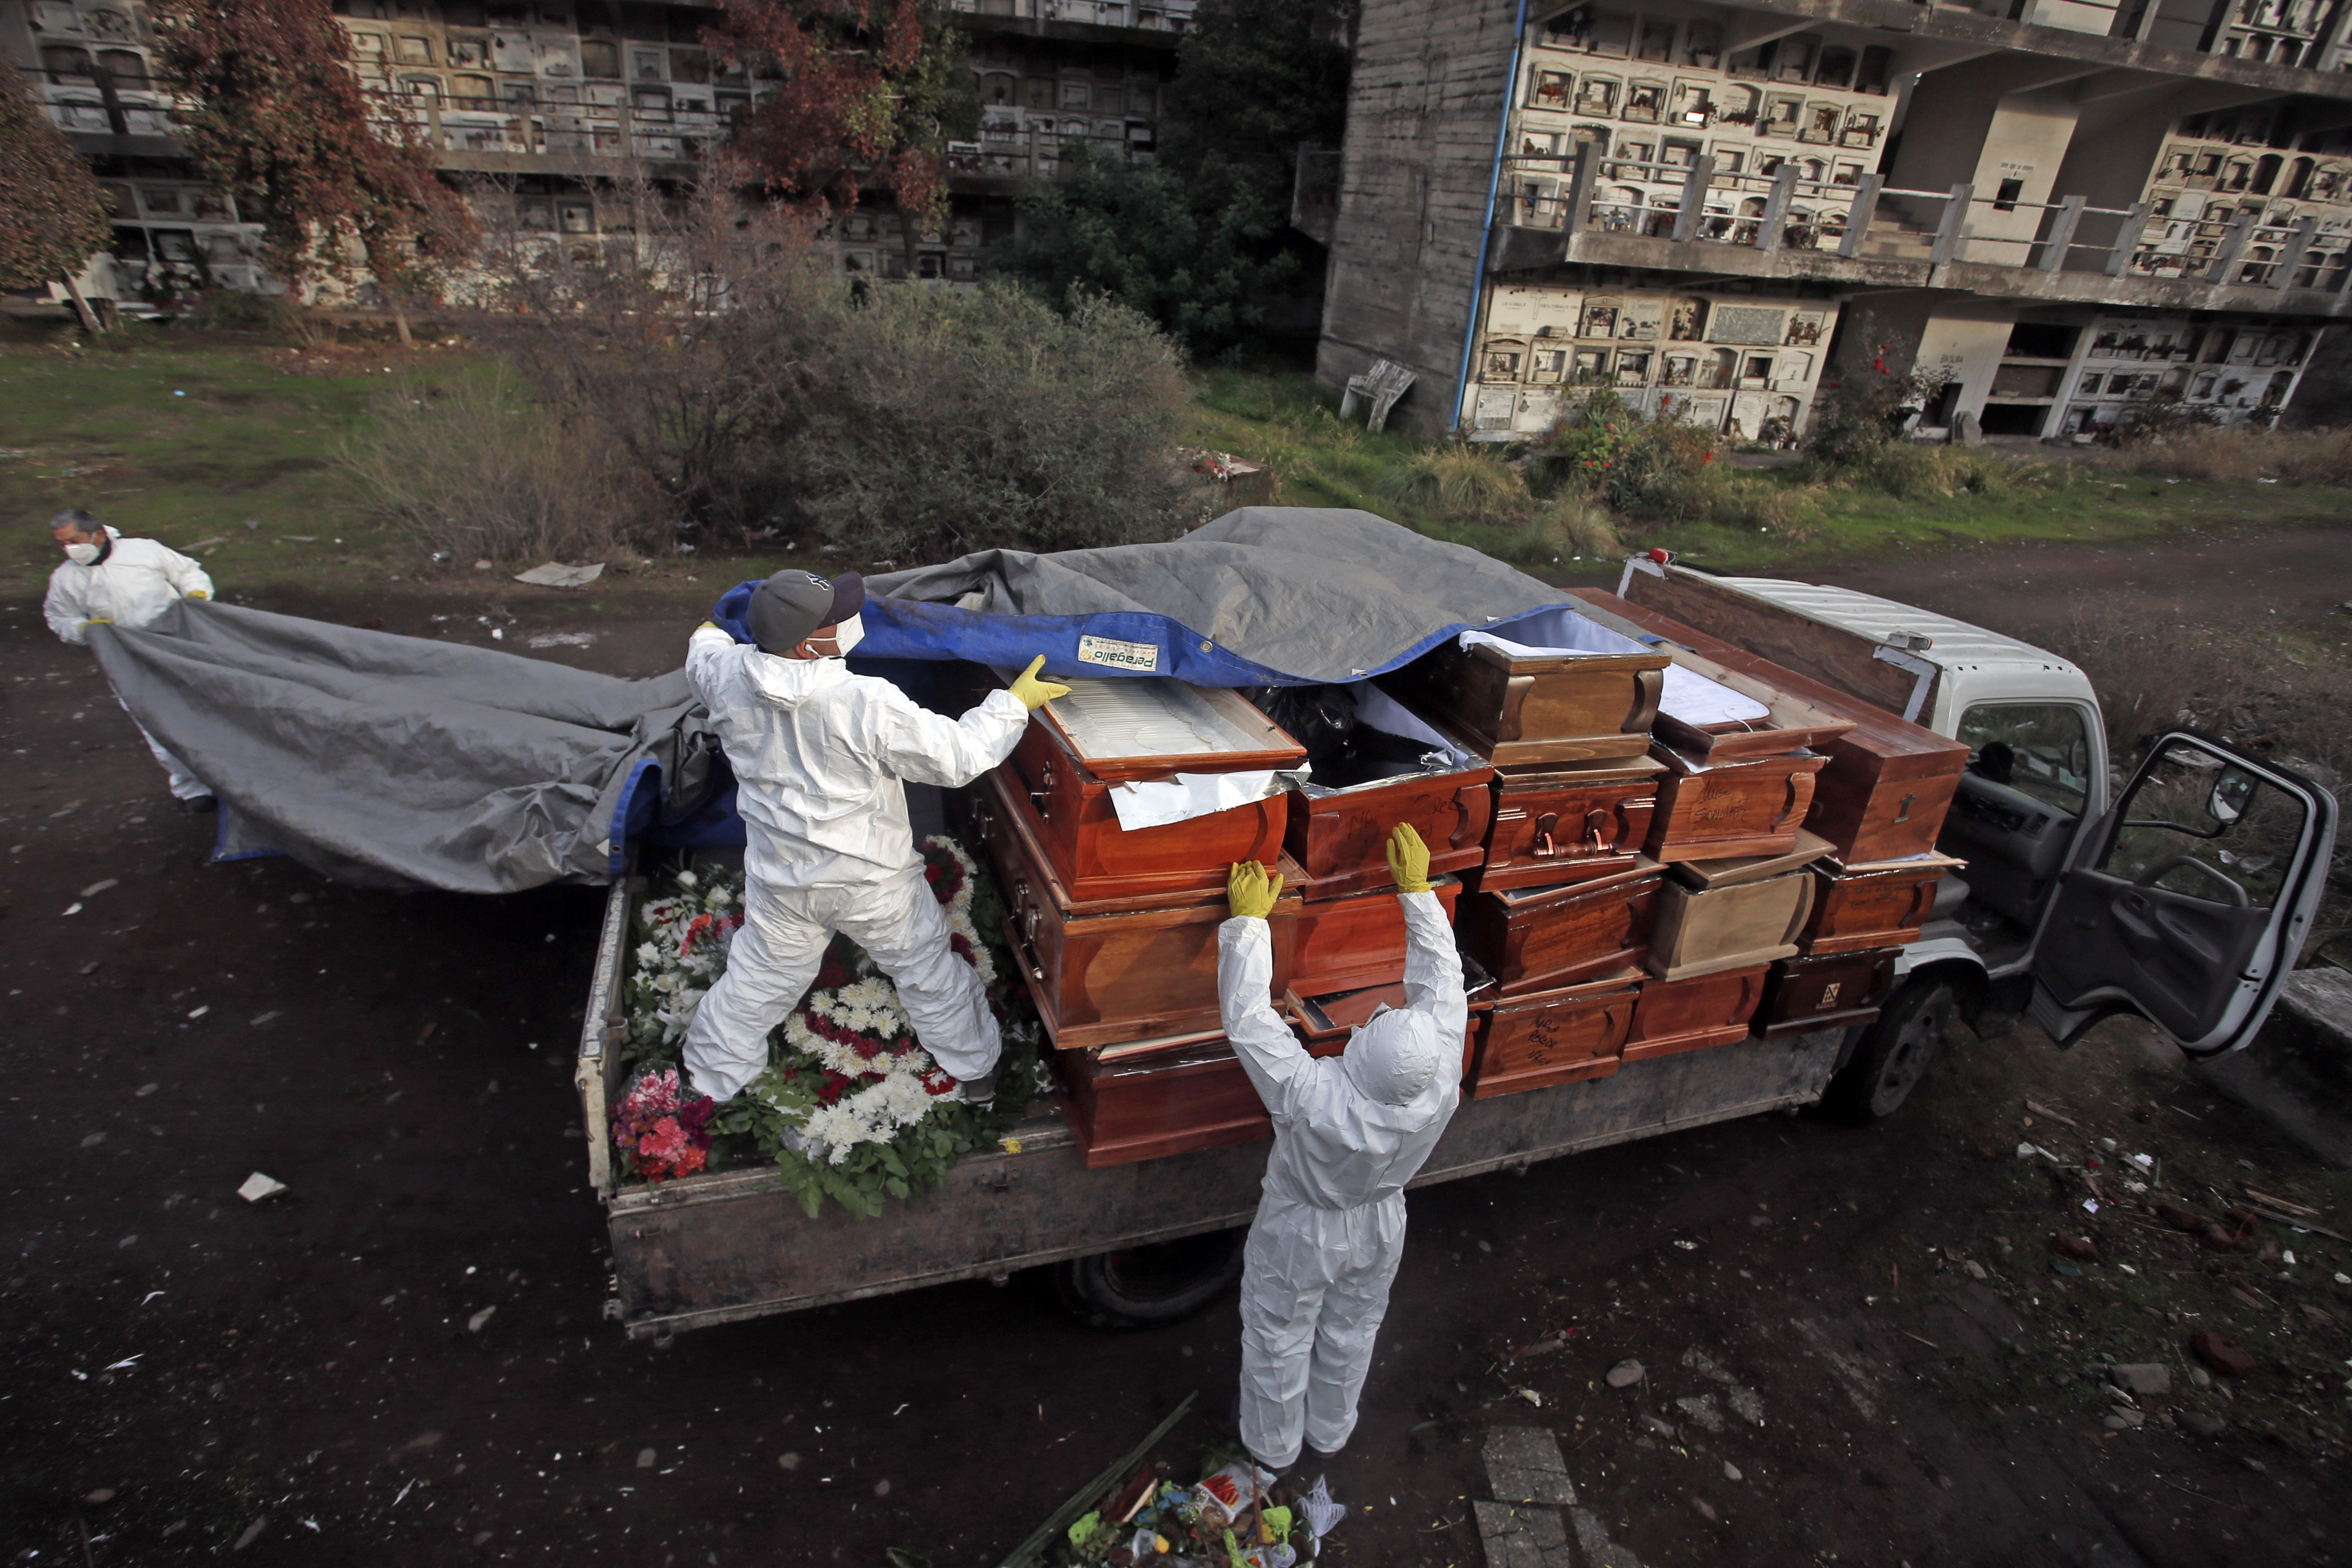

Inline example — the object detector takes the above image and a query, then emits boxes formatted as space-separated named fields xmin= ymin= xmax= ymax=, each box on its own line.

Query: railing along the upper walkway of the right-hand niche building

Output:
xmin=1496 ymin=144 xmax=2352 ymax=291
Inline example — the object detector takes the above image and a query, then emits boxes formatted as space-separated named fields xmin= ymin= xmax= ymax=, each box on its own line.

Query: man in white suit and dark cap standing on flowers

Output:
xmin=684 ymin=571 xmax=1070 ymax=1105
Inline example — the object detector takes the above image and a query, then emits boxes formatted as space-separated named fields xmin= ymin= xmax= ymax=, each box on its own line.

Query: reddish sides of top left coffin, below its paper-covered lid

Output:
xmin=995 ymin=724 xmax=1291 ymax=903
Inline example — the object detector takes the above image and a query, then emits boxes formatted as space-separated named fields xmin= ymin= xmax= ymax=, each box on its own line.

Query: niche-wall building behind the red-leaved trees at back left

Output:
xmin=0 ymin=0 xmax=1193 ymax=301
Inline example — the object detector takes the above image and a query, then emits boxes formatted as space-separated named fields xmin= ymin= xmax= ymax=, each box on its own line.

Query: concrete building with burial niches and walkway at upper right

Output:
xmin=1317 ymin=0 xmax=2352 ymax=440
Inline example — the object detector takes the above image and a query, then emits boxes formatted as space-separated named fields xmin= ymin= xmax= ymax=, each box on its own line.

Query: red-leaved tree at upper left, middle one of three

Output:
xmin=151 ymin=0 xmax=478 ymax=339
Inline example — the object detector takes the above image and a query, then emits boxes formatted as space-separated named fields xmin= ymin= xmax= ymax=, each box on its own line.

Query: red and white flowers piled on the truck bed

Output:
xmin=614 ymin=837 xmax=1037 ymax=1215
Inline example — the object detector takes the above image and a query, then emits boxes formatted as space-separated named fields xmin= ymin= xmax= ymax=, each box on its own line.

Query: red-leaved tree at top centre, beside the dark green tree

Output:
xmin=703 ymin=0 xmax=981 ymax=245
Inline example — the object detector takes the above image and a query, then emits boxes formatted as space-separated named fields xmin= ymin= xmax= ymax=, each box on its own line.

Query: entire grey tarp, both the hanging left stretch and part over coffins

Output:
xmin=92 ymin=506 xmax=1562 ymax=893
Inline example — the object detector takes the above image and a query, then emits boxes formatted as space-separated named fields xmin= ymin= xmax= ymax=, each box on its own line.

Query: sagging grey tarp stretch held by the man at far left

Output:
xmin=89 ymin=602 xmax=717 ymax=893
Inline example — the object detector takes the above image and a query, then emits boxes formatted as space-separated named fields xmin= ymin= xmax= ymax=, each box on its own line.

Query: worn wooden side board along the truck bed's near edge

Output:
xmin=609 ymin=1030 xmax=1842 ymax=1337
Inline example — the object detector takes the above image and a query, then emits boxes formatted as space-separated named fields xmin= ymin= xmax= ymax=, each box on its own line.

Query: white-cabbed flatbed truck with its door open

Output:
xmin=576 ymin=557 xmax=2336 ymax=1337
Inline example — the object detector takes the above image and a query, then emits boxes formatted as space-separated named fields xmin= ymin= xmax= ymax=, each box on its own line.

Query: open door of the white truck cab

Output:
xmin=2032 ymin=729 xmax=2336 ymax=1058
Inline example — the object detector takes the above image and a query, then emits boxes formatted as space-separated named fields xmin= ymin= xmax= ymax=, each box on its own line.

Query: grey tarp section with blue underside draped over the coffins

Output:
xmin=866 ymin=506 xmax=1564 ymax=686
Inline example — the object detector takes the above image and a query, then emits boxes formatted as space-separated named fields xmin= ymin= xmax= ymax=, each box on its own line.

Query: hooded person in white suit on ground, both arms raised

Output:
xmin=1216 ymin=823 xmax=1470 ymax=1472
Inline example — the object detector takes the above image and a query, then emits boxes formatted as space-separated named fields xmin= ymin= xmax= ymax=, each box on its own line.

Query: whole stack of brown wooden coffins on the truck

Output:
xmin=971 ymin=595 xmax=1966 ymax=1166
